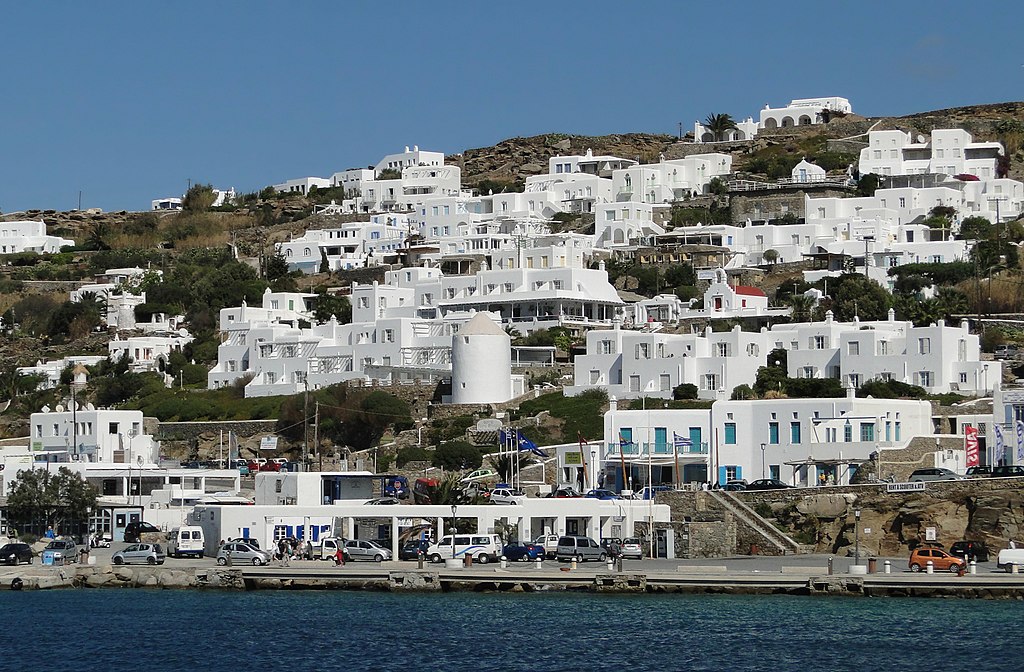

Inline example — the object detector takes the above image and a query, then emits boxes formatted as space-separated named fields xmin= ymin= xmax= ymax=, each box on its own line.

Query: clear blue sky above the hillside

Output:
xmin=0 ymin=0 xmax=1024 ymax=212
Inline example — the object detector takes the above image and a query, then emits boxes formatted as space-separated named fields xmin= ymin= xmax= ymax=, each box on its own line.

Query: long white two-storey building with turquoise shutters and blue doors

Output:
xmin=598 ymin=394 xmax=937 ymax=491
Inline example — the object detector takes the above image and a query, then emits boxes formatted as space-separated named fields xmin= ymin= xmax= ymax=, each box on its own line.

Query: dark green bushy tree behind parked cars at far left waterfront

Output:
xmin=7 ymin=467 xmax=97 ymax=533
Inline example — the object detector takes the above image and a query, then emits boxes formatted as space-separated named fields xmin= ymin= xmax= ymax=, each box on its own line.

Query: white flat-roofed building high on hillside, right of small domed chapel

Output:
xmin=858 ymin=128 xmax=1005 ymax=180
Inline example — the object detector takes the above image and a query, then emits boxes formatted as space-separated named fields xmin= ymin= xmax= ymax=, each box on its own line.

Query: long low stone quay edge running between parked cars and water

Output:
xmin=8 ymin=564 xmax=1024 ymax=599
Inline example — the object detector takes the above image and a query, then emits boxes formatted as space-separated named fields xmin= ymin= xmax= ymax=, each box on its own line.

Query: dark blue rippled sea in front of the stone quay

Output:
xmin=0 ymin=589 xmax=1024 ymax=672
